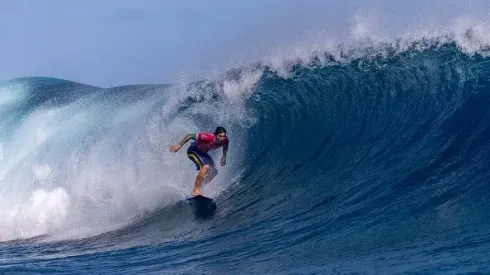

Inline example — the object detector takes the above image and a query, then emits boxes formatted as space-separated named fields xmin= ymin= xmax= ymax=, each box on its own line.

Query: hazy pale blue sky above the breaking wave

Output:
xmin=0 ymin=0 xmax=490 ymax=87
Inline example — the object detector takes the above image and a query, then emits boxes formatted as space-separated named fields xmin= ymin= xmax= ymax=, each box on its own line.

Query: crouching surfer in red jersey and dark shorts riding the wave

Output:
xmin=169 ymin=127 xmax=229 ymax=196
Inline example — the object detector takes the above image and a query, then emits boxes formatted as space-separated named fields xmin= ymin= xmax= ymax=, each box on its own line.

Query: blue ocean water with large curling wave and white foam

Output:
xmin=0 ymin=40 xmax=490 ymax=274
